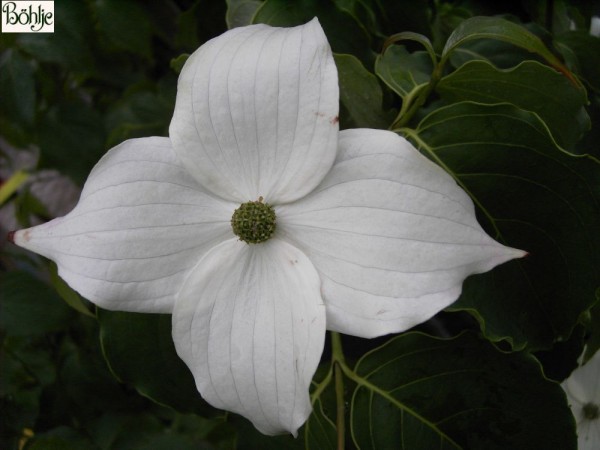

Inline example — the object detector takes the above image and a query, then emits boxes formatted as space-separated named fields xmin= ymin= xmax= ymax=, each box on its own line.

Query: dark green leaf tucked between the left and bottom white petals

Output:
xmin=98 ymin=309 xmax=213 ymax=413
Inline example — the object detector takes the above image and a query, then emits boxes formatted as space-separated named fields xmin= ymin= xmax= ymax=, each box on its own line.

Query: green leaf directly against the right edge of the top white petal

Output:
xmin=335 ymin=55 xmax=394 ymax=129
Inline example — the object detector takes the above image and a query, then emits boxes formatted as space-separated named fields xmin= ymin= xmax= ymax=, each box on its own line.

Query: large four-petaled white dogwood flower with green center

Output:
xmin=12 ymin=19 xmax=524 ymax=434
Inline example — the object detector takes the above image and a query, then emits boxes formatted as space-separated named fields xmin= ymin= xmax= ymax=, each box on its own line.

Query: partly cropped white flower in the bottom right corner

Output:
xmin=562 ymin=352 xmax=600 ymax=450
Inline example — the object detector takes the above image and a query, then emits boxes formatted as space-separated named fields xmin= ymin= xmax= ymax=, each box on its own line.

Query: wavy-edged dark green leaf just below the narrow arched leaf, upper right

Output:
xmin=436 ymin=61 xmax=591 ymax=150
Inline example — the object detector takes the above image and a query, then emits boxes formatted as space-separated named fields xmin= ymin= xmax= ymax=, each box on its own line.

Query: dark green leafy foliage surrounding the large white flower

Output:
xmin=0 ymin=0 xmax=600 ymax=450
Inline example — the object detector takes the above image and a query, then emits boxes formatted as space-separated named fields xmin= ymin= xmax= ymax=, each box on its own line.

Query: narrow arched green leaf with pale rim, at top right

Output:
xmin=442 ymin=17 xmax=578 ymax=85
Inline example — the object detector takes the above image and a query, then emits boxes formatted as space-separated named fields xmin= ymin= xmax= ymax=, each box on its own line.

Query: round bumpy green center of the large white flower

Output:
xmin=231 ymin=197 xmax=276 ymax=244
